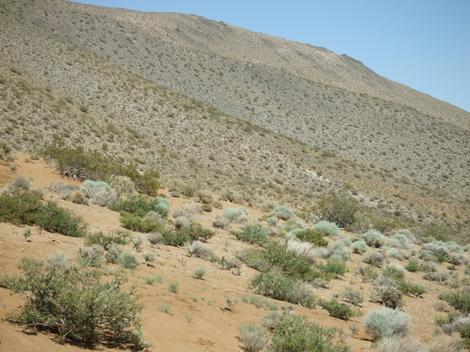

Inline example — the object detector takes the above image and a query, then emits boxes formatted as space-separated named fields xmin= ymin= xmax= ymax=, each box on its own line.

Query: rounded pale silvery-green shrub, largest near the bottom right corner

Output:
xmin=364 ymin=308 xmax=410 ymax=339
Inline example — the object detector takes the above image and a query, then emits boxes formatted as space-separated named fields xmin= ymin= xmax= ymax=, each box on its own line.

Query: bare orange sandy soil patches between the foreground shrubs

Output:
xmin=0 ymin=155 xmax=456 ymax=352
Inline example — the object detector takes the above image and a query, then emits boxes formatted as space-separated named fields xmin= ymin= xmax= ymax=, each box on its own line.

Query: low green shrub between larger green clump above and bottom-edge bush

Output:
xmin=251 ymin=271 xmax=315 ymax=307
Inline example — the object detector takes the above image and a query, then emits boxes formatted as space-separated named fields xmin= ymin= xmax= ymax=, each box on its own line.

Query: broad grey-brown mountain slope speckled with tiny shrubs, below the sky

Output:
xmin=0 ymin=0 xmax=470 ymax=228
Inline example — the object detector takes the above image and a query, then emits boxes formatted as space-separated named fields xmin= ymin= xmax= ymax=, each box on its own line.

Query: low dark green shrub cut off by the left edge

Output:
xmin=0 ymin=192 xmax=86 ymax=237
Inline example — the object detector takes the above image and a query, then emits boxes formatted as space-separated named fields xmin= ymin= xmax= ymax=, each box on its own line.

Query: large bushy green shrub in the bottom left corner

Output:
xmin=2 ymin=258 xmax=144 ymax=349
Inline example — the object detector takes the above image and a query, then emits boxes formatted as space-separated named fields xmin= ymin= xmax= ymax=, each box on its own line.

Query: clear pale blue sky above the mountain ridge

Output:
xmin=73 ymin=0 xmax=470 ymax=111
